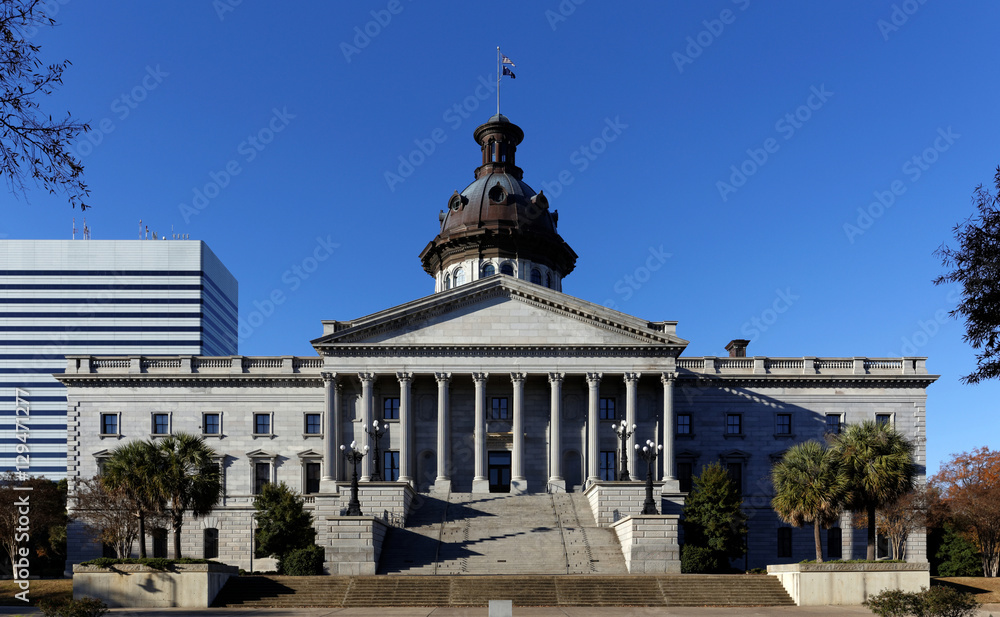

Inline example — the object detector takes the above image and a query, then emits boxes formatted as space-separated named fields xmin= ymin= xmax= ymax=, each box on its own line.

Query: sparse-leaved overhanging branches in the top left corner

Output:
xmin=0 ymin=0 xmax=89 ymax=210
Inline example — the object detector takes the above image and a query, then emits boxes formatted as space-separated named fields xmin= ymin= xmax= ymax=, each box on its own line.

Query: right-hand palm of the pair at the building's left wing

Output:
xmin=157 ymin=433 xmax=222 ymax=559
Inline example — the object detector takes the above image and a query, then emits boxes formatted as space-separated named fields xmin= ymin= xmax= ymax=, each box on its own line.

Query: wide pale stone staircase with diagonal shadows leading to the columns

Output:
xmin=378 ymin=493 xmax=627 ymax=576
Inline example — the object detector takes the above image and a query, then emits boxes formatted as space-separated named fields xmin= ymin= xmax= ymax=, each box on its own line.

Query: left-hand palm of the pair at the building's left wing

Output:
xmin=100 ymin=440 xmax=166 ymax=557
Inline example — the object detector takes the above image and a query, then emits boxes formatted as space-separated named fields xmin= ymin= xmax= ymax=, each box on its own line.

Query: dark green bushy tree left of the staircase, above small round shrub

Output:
xmin=254 ymin=482 xmax=316 ymax=560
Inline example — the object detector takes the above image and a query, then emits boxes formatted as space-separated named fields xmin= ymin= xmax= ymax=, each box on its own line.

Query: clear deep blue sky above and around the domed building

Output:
xmin=0 ymin=0 xmax=1000 ymax=472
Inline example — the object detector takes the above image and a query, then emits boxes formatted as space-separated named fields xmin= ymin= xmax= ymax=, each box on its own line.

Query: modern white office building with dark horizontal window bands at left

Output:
xmin=0 ymin=240 xmax=237 ymax=479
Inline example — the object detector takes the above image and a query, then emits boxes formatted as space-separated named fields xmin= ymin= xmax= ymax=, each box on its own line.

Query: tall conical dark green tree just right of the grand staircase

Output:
xmin=683 ymin=462 xmax=747 ymax=571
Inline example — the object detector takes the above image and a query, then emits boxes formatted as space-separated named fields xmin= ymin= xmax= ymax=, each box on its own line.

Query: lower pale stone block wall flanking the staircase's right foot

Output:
xmin=611 ymin=514 xmax=681 ymax=574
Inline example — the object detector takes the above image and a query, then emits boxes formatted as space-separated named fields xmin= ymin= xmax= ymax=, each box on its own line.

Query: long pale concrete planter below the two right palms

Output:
xmin=767 ymin=562 xmax=931 ymax=606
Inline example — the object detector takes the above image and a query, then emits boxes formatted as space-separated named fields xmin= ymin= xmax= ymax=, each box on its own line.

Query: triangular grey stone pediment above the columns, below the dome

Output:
xmin=312 ymin=276 xmax=687 ymax=354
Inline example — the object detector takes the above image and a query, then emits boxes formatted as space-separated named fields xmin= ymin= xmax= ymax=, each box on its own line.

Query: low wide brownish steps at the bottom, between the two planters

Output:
xmin=213 ymin=574 xmax=793 ymax=608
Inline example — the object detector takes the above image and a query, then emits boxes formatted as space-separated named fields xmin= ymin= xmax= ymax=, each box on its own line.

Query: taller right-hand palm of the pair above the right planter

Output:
xmin=832 ymin=420 xmax=916 ymax=560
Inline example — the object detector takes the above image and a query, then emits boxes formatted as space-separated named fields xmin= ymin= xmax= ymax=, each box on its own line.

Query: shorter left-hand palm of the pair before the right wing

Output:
xmin=771 ymin=441 xmax=847 ymax=562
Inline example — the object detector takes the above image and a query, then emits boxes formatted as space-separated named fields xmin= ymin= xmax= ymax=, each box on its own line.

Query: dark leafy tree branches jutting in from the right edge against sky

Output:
xmin=934 ymin=167 xmax=1000 ymax=383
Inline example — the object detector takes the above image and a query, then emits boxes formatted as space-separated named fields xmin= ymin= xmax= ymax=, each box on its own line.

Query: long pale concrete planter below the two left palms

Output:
xmin=73 ymin=563 xmax=239 ymax=608
